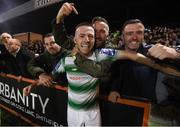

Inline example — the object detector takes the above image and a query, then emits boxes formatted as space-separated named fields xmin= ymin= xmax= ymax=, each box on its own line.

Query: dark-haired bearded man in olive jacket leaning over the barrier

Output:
xmin=28 ymin=33 xmax=68 ymax=86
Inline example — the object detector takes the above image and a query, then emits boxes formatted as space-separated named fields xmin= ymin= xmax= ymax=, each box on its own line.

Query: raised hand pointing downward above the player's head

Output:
xmin=56 ymin=2 xmax=78 ymax=24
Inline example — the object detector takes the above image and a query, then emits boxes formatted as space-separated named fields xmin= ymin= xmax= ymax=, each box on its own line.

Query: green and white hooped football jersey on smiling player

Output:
xmin=52 ymin=49 xmax=117 ymax=110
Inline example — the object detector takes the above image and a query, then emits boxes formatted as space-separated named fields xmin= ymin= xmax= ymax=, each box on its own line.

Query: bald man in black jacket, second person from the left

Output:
xmin=3 ymin=39 xmax=35 ymax=78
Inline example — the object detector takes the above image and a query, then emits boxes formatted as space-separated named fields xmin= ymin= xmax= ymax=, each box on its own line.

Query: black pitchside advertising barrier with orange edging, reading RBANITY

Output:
xmin=0 ymin=73 xmax=150 ymax=126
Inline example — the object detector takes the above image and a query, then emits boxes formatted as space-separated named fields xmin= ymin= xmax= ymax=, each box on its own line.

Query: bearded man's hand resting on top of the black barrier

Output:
xmin=38 ymin=73 xmax=53 ymax=87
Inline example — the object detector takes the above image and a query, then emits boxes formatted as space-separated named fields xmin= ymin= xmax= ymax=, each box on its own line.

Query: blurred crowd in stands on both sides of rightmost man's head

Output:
xmin=110 ymin=26 xmax=180 ymax=47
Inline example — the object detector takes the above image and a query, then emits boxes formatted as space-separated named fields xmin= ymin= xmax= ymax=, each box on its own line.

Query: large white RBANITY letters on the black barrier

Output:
xmin=0 ymin=82 xmax=49 ymax=114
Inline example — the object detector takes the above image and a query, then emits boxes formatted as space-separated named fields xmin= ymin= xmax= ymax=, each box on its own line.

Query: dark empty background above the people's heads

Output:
xmin=0 ymin=0 xmax=180 ymax=34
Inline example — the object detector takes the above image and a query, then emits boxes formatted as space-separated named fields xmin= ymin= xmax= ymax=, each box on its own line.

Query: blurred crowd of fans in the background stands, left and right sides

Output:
xmin=10 ymin=26 xmax=180 ymax=54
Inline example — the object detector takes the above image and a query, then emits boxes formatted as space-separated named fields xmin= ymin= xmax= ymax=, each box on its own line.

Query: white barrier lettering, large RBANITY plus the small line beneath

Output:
xmin=0 ymin=82 xmax=63 ymax=127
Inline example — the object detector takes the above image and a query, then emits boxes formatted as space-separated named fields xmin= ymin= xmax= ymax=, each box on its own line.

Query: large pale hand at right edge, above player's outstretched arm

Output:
xmin=148 ymin=44 xmax=179 ymax=60
